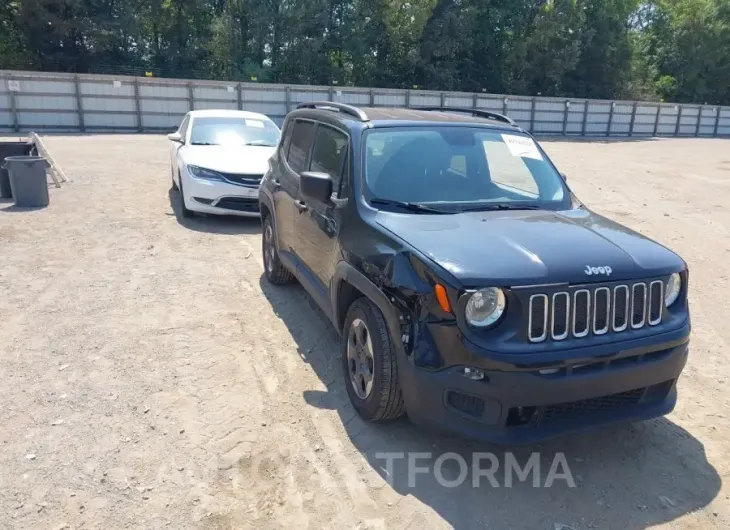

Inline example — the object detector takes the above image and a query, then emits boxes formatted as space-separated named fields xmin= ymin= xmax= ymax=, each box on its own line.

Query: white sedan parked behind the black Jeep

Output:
xmin=168 ymin=110 xmax=281 ymax=217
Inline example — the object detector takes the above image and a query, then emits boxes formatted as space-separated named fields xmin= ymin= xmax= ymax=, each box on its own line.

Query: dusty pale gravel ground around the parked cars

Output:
xmin=0 ymin=136 xmax=730 ymax=530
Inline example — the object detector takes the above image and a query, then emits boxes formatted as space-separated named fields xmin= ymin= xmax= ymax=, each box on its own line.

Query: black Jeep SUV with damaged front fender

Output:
xmin=260 ymin=102 xmax=690 ymax=443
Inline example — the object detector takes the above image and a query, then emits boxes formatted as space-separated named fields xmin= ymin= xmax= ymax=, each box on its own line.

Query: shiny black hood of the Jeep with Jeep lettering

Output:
xmin=376 ymin=209 xmax=684 ymax=286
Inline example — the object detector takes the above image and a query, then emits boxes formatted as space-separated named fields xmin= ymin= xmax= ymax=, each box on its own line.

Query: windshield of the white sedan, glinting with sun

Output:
xmin=190 ymin=118 xmax=279 ymax=147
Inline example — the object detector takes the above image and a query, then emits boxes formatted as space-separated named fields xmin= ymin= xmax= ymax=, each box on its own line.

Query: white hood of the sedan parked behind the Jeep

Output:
xmin=180 ymin=145 xmax=276 ymax=175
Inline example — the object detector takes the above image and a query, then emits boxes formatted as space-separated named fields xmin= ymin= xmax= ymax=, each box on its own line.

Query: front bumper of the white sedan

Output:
xmin=183 ymin=172 xmax=259 ymax=217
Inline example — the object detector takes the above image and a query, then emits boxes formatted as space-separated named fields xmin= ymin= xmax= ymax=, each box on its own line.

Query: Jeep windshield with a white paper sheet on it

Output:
xmin=365 ymin=126 xmax=568 ymax=211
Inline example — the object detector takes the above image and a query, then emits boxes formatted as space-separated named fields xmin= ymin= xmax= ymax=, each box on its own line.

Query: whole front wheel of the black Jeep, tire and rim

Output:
xmin=342 ymin=298 xmax=405 ymax=421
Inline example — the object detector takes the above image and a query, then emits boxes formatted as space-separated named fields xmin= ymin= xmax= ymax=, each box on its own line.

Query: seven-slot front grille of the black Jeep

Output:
xmin=528 ymin=280 xmax=664 ymax=342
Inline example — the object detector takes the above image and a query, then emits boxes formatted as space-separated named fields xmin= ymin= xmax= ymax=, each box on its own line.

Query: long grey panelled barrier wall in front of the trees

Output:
xmin=0 ymin=70 xmax=730 ymax=137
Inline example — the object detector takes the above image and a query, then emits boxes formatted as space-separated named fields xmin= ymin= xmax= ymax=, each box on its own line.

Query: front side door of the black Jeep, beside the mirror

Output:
xmin=294 ymin=123 xmax=350 ymax=304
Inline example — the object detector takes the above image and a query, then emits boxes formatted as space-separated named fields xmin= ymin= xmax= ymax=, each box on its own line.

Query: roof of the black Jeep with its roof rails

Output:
xmin=297 ymin=101 xmax=517 ymax=127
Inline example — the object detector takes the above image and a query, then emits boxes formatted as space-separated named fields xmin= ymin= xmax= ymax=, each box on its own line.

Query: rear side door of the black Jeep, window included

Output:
xmin=273 ymin=119 xmax=315 ymax=260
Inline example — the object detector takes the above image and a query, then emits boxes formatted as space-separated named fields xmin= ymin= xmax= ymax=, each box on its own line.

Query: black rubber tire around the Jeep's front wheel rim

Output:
xmin=341 ymin=298 xmax=405 ymax=421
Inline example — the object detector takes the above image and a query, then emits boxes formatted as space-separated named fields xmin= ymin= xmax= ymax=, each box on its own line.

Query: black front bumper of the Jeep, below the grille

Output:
xmin=399 ymin=328 xmax=689 ymax=444
